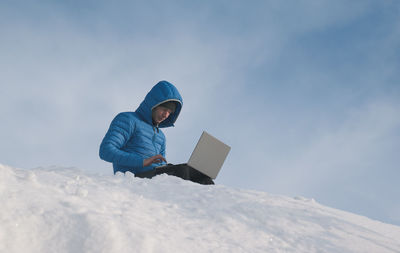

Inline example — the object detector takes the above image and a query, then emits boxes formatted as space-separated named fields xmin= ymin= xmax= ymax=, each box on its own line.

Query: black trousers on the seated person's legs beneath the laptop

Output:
xmin=135 ymin=164 xmax=214 ymax=185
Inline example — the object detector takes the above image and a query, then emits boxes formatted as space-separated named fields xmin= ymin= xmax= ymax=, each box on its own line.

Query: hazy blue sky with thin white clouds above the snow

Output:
xmin=0 ymin=0 xmax=400 ymax=225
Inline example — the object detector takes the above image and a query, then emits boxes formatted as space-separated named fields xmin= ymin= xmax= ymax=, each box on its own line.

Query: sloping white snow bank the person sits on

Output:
xmin=0 ymin=165 xmax=400 ymax=253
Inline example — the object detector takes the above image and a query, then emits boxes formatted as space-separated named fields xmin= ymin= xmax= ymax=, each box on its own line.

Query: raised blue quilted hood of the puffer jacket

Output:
xmin=136 ymin=81 xmax=183 ymax=128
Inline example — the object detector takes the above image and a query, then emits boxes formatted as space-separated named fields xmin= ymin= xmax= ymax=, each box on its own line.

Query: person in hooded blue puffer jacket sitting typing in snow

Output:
xmin=99 ymin=81 xmax=214 ymax=184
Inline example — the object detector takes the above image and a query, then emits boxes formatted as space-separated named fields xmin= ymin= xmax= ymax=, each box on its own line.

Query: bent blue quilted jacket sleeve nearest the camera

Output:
xmin=99 ymin=113 xmax=143 ymax=168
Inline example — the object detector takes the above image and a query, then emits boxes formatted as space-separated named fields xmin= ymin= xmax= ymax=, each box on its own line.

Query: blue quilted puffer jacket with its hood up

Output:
xmin=99 ymin=81 xmax=183 ymax=173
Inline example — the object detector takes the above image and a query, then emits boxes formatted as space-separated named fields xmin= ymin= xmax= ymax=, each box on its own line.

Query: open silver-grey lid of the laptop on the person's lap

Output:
xmin=187 ymin=131 xmax=231 ymax=179
